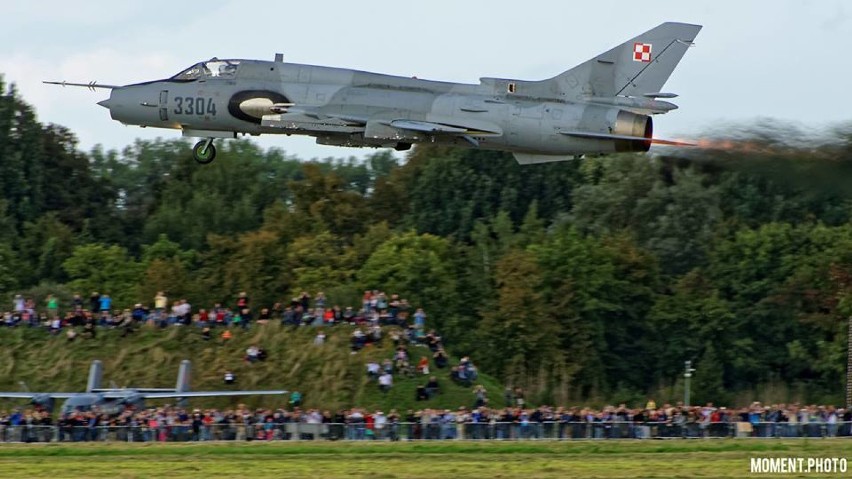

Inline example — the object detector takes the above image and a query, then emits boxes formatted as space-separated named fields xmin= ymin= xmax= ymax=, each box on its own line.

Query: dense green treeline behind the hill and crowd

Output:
xmin=0 ymin=77 xmax=852 ymax=404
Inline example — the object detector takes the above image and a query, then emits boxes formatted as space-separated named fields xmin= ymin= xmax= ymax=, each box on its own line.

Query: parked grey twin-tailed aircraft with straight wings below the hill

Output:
xmin=0 ymin=359 xmax=287 ymax=414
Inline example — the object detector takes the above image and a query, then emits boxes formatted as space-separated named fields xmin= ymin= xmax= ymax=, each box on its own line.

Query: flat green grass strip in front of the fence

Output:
xmin=0 ymin=439 xmax=852 ymax=479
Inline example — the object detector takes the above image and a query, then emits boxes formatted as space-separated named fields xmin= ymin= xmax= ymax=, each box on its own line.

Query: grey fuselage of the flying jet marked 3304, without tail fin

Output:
xmin=105 ymin=60 xmax=662 ymax=155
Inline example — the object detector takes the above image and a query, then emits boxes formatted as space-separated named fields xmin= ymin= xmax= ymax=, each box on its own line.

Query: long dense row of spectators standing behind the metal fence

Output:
xmin=5 ymin=401 xmax=852 ymax=442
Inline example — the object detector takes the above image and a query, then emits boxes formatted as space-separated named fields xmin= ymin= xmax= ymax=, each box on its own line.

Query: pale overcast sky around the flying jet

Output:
xmin=0 ymin=0 xmax=852 ymax=159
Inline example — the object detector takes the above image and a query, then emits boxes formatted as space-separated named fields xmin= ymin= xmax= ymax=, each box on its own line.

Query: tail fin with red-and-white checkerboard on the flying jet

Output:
xmin=545 ymin=22 xmax=701 ymax=97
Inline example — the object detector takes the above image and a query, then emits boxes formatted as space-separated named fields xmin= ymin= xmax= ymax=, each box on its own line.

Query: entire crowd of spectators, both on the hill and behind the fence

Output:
xmin=6 ymin=291 xmax=852 ymax=441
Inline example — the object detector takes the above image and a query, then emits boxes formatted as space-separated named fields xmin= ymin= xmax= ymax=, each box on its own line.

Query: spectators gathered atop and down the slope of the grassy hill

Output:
xmin=4 ymin=290 xmax=486 ymax=402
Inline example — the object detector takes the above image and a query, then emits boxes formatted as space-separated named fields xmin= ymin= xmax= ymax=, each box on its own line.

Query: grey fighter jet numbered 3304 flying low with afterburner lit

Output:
xmin=45 ymin=23 xmax=701 ymax=164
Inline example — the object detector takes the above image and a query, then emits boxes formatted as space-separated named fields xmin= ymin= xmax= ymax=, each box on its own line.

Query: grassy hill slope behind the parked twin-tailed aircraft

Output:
xmin=0 ymin=324 xmax=503 ymax=412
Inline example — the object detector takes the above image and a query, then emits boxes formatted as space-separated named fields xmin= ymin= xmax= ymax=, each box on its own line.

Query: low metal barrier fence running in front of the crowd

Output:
xmin=0 ymin=422 xmax=852 ymax=442
